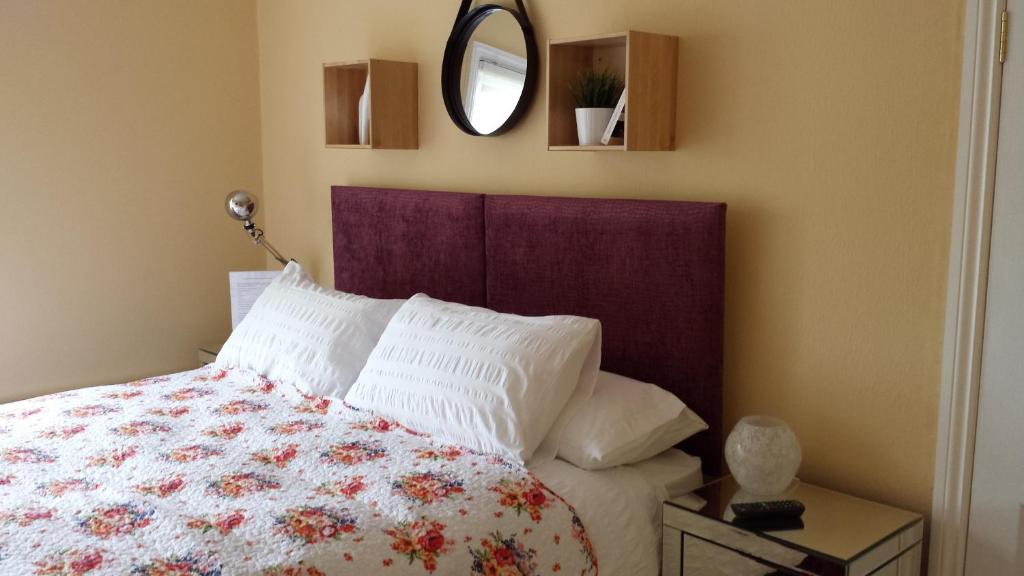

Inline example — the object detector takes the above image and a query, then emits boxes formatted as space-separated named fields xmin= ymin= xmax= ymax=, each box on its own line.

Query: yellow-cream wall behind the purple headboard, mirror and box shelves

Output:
xmin=258 ymin=0 xmax=962 ymax=520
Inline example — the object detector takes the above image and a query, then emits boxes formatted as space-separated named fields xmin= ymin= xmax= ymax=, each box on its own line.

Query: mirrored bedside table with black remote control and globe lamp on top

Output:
xmin=662 ymin=477 xmax=924 ymax=576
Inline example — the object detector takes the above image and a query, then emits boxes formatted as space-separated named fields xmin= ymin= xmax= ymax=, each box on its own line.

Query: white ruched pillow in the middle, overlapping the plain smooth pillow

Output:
xmin=345 ymin=294 xmax=601 ymax=462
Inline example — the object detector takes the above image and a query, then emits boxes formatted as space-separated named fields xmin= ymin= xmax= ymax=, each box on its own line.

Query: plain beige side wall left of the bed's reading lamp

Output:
xmin=0 ymin=0 xmax=264 ymax=402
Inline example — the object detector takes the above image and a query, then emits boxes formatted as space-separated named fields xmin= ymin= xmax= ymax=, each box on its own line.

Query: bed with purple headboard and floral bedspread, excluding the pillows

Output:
xmin=0 ymin=187 xmax=725 ymax=576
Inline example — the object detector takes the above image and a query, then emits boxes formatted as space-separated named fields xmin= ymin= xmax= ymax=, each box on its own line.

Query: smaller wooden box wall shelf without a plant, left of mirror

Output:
xmin=324 ymin=59 xmax=420 ymax=150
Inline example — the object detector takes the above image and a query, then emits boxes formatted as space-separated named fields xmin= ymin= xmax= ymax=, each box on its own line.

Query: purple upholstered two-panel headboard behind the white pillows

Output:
xmin=332 ymin=187 xmax=725 ymax=474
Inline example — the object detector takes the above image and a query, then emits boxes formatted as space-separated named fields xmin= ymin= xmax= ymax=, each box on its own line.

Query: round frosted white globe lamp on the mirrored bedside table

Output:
xmin=725 ymin=416 xmax=803 ymax=496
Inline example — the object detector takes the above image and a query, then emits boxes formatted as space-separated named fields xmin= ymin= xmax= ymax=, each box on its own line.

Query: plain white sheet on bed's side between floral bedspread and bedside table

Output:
xmin=530 ymin=450 xmax=702 ymax=576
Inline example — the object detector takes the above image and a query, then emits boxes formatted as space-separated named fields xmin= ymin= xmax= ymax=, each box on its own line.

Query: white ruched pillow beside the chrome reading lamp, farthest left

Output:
xmin=216 ymin=262 xmax=403 ymax=398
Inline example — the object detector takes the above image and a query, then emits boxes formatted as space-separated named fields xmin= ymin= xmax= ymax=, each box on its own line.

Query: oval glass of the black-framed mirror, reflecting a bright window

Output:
xmin=461 ymin=10 xmax=526 ymax=134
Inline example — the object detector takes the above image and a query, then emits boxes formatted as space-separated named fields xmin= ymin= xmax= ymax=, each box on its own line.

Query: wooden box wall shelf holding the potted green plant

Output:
xmin=548 ymin=31 xmax=679 ymax=151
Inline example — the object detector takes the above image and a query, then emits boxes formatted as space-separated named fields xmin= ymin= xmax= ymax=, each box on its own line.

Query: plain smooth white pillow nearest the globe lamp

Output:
xmin=558 ymin=371 xmax=708 ymax=470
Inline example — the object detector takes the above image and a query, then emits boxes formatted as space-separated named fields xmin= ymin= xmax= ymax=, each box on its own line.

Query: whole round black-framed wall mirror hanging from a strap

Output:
xmin=441 ymin=0 xmax=538 ymax=136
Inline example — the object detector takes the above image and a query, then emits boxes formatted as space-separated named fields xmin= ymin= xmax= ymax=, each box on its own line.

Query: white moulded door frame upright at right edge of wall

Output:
xmin=929 ymin=0 xmax=1007 ymax=576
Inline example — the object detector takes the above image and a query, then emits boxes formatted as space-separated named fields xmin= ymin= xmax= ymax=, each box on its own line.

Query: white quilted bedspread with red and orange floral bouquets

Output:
xmin=0 ymin=367 xmax=598 ymax=576
